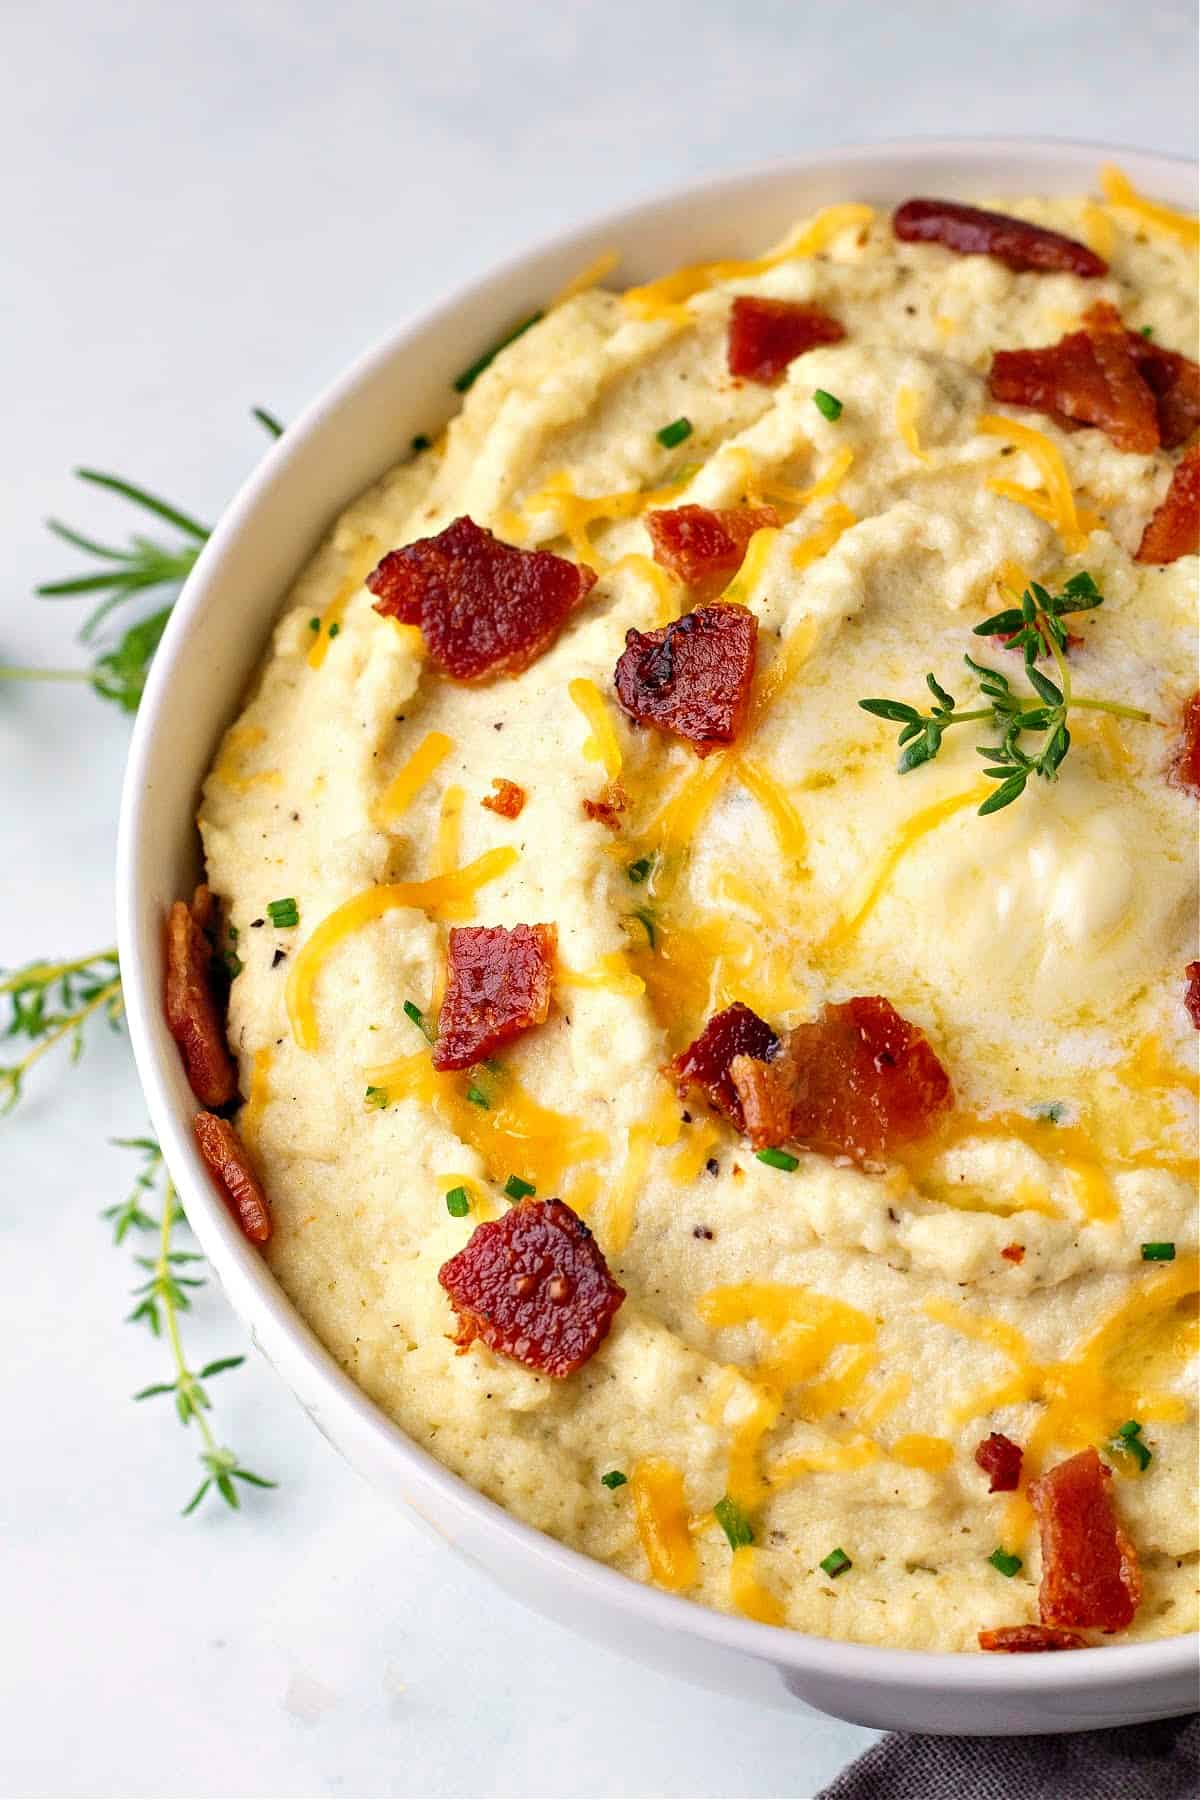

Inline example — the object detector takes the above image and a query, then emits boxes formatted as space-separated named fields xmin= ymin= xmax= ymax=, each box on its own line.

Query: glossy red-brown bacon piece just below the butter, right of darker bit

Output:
xmin=729 ymin=994 xmax=954 ymax=1163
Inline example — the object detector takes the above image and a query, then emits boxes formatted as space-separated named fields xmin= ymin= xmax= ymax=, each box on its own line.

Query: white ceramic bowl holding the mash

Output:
xmin=117 ymin=140 xmax=1196 ymax=1733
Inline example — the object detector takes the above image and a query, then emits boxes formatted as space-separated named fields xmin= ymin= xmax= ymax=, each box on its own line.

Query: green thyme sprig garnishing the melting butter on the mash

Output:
xmin=858 ymin=571 xmax=1150 ymax=817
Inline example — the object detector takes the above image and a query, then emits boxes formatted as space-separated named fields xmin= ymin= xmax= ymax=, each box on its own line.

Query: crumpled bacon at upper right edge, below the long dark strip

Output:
xmin=988 ymin=301 xmax=1200 ymax=454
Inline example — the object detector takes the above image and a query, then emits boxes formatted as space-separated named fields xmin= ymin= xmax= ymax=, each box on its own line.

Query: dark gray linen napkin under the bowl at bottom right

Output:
xmin=817 ymin=1715 xmax=1200 ymax=1800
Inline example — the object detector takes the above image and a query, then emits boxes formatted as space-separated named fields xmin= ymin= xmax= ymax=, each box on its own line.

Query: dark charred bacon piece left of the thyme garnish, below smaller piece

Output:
xmin=613 ymin=607 xmax=757 ymax=756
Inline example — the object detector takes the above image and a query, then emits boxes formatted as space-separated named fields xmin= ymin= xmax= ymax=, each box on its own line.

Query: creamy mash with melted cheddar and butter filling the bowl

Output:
xmin=200 ymin=189 xmax=1196 ymax=1649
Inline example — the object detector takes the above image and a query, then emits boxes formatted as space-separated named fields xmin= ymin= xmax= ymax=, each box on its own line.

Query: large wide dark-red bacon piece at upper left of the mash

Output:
xmin=367 ymin=518 xmax=596 ymax=680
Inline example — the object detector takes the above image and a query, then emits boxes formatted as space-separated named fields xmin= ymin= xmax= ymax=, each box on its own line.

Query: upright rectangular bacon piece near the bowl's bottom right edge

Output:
xmin=1029 ymin=1445 xmax=1142 ymax=1631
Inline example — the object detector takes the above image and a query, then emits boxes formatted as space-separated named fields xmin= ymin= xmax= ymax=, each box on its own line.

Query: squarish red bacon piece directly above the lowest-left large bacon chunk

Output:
xmin=434 ymin=925 xmax=558 ymax=1069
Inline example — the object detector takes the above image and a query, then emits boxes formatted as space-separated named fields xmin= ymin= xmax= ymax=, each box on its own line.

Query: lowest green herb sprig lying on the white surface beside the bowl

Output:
xmin=117 ymin=1138 xmax=277 ymax=1517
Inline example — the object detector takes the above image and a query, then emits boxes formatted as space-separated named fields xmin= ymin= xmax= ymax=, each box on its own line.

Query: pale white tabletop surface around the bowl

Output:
xmin=0 ymin=0 xmax=1195 ymax=1796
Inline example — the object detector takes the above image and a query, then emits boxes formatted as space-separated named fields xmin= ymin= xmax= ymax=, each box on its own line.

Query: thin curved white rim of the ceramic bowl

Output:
xmin=117 ymin=135 xmax=1200 ymax=1692
